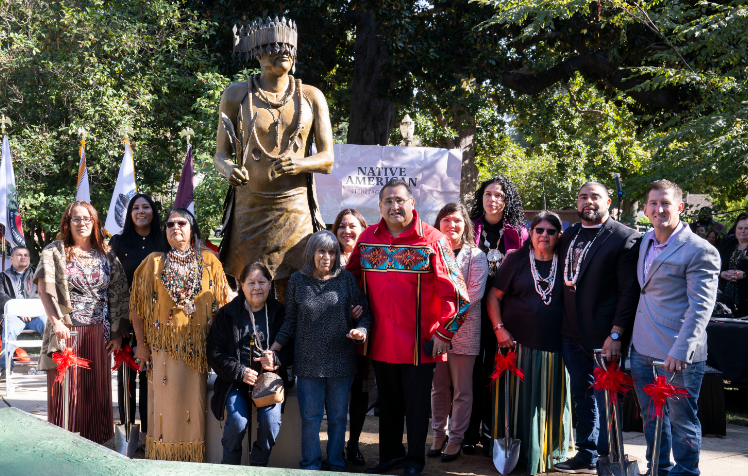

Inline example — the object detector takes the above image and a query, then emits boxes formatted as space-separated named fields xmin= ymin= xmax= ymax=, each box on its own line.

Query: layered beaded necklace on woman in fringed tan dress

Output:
xmin=161 ymin=248 xmax=203 ymax=319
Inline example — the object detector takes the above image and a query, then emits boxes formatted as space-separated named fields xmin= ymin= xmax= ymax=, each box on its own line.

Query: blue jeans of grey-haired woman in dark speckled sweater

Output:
xmin=296 ymin=375 xmax=353 ymax=471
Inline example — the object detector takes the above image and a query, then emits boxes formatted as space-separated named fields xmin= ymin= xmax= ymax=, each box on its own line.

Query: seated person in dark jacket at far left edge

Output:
xmin=0 ymin=246 xmax=47 ymax=378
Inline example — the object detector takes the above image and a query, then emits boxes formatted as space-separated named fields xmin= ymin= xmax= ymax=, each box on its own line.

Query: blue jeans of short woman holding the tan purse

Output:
xmin=221 ymin=388 xmax=281 ymax=465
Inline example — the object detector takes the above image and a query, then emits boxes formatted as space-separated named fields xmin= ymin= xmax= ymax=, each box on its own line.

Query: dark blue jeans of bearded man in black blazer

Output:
xmin=561 ymin=337 xmax=612 ymax=465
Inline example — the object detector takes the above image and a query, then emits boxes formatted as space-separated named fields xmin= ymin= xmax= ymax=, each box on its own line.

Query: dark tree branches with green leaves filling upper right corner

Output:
xmin=480 ymin=0 xmax=748 ymax=205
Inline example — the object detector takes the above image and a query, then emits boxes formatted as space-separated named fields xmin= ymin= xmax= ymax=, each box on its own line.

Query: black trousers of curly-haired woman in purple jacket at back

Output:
xmin=462 ymin=300 xmax=498 ymax=449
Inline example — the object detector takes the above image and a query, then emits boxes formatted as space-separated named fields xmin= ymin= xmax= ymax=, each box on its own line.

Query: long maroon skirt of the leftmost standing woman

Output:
xmin=47 ymin=324 xmax=114 ymax=445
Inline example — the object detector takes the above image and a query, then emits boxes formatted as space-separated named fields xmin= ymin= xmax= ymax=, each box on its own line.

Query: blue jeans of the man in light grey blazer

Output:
xmin=631 ymin=348 xmax=706 ymax=476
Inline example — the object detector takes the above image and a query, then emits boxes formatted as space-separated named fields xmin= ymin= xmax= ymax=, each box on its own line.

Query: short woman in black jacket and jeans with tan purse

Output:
xmin=206 ymin=262 xmax=293 ymax=466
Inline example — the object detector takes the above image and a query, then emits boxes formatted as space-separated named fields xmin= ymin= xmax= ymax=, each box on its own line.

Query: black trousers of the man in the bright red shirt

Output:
xmin=374 ymin=360 xmax=436 ymax=471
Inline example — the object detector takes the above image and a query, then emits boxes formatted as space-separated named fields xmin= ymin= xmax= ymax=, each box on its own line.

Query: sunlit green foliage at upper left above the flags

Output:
xmin=0 ymin=0 xmax=213 ymax=253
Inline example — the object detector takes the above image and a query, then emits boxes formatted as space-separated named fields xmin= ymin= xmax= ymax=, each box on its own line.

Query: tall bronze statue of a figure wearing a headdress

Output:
xmin=213 ymin=17 xmax=333 ymax=297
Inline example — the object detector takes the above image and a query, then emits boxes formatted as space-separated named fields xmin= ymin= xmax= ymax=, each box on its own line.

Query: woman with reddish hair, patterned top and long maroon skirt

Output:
xmin=34 ymin=201 xmax=129 ymax=444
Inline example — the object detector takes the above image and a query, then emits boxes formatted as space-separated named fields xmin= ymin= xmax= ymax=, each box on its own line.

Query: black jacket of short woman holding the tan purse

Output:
xmin=206 ymin=290 xmax=294 ymax=421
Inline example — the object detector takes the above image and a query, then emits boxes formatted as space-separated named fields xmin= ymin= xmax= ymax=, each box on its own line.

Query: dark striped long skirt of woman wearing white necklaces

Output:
xmin=492 ymin=344 xmax=573 ymax=474
